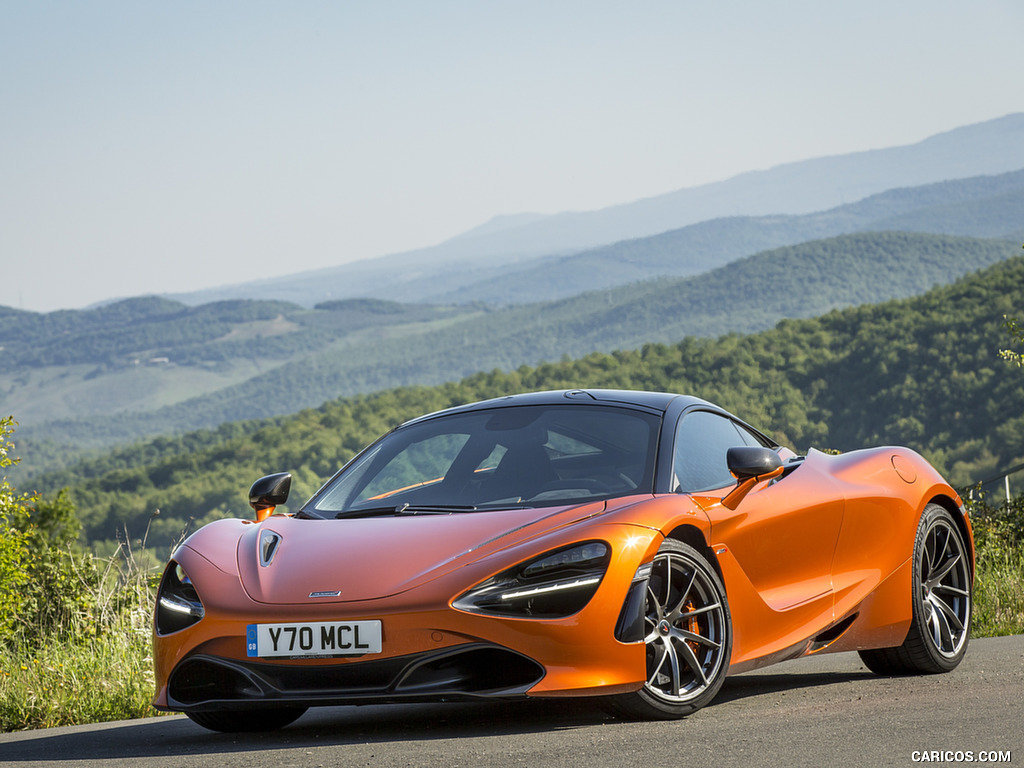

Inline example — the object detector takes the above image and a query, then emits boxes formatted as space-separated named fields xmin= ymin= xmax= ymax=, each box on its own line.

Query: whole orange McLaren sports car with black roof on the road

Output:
xmin=154 ymin=390 xmax=974 ymax=731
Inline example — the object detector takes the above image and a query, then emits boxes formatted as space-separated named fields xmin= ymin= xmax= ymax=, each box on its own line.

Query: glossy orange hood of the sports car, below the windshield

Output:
xmin=237 ymin=500 xmax=623 ymax=605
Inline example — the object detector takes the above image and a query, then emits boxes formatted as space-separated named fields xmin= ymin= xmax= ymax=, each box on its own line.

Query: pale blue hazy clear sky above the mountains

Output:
xmin=0 ymin=0 xmax=1024 ymax=311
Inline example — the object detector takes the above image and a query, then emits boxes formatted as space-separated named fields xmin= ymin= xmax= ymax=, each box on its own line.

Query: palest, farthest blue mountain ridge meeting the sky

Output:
xmin=167 ymin=114 xmax=1024 ymax=306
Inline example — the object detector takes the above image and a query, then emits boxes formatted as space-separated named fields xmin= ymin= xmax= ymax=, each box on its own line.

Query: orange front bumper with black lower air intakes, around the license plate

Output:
xmin=153 ymin=524 xmax=660 ymax=712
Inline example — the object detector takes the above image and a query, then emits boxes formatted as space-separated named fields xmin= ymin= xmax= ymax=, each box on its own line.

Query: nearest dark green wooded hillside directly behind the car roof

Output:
xmin=37 ymin=257 xmax=1024 ymax=557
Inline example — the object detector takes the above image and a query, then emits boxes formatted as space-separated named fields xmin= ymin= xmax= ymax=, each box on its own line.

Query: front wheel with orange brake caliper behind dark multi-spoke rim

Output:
xmin=609 ymin=539 xmax=732 ymax=720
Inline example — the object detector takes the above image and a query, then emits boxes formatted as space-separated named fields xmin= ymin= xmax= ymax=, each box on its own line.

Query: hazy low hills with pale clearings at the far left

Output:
xmin=0 ymin=297 xmax=480 ymax=430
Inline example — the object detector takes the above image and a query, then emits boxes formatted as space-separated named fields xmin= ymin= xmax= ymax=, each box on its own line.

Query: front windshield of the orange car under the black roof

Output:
xmin=306 ymin=404 xmax=660 ymax=517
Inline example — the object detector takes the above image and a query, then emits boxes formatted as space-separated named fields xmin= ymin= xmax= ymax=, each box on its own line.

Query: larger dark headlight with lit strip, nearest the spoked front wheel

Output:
xmin=452 ymin=542 xmax=611 ymax=618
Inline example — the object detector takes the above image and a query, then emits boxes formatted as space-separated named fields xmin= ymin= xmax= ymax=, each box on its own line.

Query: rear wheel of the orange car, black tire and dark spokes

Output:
xmin=860 ymin=504 xmax=973 ymax=675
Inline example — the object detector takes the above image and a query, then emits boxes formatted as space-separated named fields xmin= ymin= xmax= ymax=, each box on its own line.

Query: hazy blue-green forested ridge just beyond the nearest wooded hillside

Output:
xmin=19 ymin=232 xmax=1020 ymax=479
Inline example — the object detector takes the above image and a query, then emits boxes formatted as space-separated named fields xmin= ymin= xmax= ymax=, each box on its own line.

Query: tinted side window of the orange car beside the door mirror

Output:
xmin=673 ymin=411 xmax=760 ymax=493
